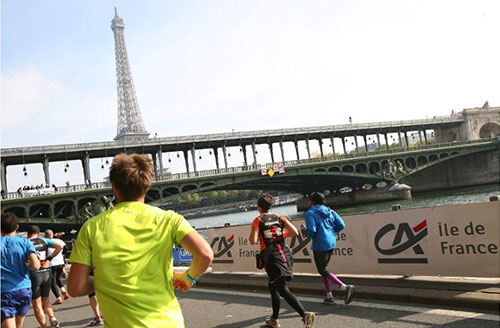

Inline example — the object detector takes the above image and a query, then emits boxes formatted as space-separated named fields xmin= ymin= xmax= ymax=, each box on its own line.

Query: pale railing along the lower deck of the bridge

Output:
xmin=3 ymin=138 xmax=496 ymax=199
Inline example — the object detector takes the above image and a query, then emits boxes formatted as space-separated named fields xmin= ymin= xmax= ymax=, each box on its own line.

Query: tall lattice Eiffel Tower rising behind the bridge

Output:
xmin=111 ymin=3 xmax=149 ymax=140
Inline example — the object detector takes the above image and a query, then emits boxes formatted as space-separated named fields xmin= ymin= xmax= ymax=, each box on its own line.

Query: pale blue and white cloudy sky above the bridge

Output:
xmin=1 ymin=0 xmax=500 ymax=190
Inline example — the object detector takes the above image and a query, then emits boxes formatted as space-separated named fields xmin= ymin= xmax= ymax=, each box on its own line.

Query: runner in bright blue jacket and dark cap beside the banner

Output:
xmin=301 ymin=192 xmax=354 ymax=305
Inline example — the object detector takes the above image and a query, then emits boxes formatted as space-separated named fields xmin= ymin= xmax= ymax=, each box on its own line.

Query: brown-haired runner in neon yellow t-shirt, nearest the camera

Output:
xmin=68 ymin=154 xmax=213 ymax=327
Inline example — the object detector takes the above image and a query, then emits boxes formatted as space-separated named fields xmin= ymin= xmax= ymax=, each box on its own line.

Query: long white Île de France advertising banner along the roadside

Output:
xmin=208 ymin=201 xmax=500 ymax=277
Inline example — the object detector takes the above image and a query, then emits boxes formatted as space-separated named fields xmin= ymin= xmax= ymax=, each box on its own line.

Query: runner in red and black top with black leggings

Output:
xmin=249 ymin=194 xmax=314 ymax=328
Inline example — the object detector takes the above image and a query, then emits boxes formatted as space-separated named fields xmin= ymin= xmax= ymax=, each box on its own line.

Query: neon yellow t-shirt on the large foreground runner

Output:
xmin=70 ymin=202 xmax=194 ymax=328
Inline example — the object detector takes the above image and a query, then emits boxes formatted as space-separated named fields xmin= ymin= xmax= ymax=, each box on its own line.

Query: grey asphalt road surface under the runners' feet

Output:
xmin=24 ymin=288 xmax=500 ymax=328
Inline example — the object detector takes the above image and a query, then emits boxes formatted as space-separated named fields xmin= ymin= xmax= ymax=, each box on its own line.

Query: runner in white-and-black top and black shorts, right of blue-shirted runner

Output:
xmin=28 ymin=225 xmax=63 ymax=328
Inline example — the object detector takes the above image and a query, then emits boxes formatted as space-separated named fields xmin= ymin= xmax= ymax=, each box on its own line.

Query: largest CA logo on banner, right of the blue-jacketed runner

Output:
xmin=375 ymin=220 xmax=427 ymax=264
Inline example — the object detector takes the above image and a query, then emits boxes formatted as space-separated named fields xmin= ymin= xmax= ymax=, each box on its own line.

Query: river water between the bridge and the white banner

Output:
xmin=189 ymin=184 xmax=500 ymax=229
